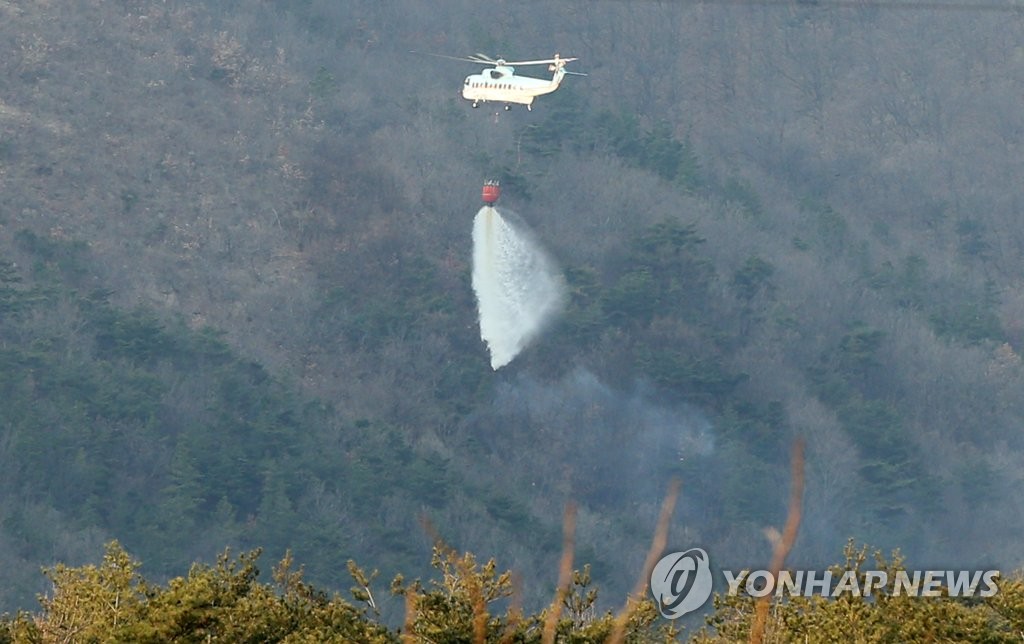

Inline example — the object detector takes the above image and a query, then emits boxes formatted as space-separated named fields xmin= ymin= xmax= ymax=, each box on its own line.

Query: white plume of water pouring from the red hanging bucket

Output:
xmin=473 ymin=206 xmax=565 ymax=371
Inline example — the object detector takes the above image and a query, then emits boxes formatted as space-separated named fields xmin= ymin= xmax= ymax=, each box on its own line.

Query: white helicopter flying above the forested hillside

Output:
xmin=430 ymin=53 xmax=587 ymax=111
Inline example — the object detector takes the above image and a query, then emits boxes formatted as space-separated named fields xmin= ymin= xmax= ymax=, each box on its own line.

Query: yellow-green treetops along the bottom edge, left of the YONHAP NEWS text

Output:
xmin=0 ymin=542 xmax=673 ymax=643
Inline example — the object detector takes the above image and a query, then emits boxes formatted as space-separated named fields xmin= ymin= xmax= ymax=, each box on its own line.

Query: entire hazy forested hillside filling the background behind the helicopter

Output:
xmin=0 ymin=0 xmax=1024 ymax=618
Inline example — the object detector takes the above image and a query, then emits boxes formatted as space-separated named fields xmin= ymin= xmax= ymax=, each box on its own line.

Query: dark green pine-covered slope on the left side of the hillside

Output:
xmin=0 ymin=253 xmax=479 ymax=602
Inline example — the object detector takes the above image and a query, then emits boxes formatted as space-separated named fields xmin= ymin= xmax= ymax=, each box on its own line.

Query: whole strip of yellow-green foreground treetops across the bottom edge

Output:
xmin=9 ymin=541 xmax=1024 ymax=643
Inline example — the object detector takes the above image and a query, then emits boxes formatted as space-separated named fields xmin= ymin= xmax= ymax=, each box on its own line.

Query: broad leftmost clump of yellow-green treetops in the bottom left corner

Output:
xmin=22 ymin=543 xmax=396 ymax=642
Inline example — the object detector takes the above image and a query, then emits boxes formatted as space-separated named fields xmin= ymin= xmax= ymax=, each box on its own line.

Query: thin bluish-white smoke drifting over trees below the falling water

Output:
xmin=475 ymin=368 xmax=721 ymax=509
